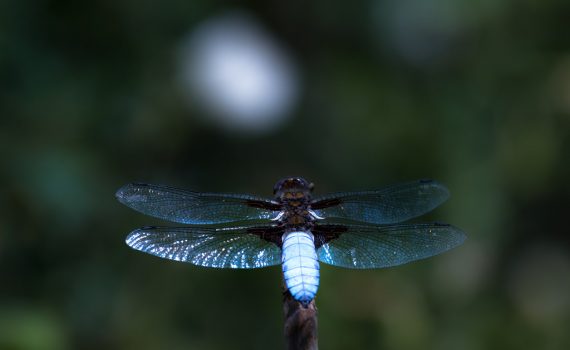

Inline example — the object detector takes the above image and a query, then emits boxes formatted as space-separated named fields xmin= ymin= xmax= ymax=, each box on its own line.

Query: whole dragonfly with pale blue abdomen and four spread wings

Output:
xmin=116 ymin=177 xmax=466 ymax=307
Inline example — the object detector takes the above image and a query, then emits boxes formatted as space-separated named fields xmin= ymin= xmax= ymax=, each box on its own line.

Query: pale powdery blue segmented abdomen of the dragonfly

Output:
xmin=281 ymin=231 xmax=319 ymax=306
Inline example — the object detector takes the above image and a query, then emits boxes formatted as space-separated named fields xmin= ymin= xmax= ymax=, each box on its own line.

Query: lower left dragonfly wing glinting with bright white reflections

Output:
xmin=126 ymin=227 xmax=281 ymax=269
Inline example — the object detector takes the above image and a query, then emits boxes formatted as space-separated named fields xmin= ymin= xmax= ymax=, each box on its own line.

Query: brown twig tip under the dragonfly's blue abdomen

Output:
xmin=283 ymin=285 xmax=318 ymax=350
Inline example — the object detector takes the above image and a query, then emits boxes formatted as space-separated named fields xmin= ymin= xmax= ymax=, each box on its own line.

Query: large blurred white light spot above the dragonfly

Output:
xmin=180 ymin=13 xmax=298 ymax=132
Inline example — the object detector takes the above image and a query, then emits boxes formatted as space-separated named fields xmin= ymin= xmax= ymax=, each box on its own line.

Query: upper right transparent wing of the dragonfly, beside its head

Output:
xmin=311 ymin=180 xmax=449 ymax=224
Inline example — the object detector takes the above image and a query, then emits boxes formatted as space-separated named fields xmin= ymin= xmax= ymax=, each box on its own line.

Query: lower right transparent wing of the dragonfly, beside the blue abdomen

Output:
xmin=317 ymin=223 xmax=466 ymax=269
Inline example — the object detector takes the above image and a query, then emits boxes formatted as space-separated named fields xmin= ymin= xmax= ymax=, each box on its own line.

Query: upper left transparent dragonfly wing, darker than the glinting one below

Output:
xmin=116 ymin=184 xmax=280 ymax=225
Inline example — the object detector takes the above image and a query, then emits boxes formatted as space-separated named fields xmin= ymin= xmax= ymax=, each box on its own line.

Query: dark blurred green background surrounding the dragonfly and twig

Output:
xmin=0 ymin=0 xmax=570 ymax=350
